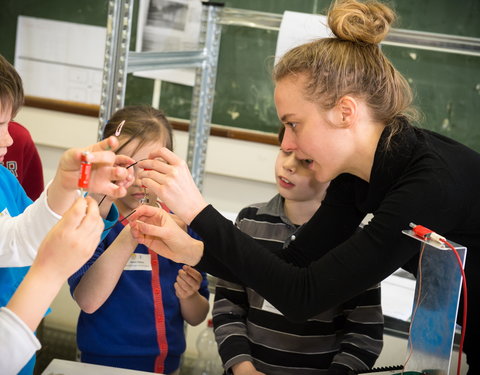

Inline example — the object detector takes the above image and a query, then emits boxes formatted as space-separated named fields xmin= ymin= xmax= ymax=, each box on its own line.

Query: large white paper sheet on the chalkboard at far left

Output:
xmin=15 ymin=16 xmax=106 ymax=104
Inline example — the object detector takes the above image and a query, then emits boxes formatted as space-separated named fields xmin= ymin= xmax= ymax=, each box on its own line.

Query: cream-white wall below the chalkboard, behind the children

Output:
xmin=16 ymin=107 xmax=467 ymax=374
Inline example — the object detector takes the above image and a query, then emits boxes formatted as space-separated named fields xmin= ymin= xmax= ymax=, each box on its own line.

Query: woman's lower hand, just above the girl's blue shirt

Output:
xmin=128 ymin=205 xmax=203 ymax=266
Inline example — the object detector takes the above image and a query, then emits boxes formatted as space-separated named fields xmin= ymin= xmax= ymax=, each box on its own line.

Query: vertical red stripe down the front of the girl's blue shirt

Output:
xmin=148 ymin=249 xmax=168 ymax=373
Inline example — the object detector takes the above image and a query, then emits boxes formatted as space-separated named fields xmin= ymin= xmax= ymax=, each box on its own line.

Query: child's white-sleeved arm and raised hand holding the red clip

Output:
xmin=0 ymin=137 xmax=131 ymax=267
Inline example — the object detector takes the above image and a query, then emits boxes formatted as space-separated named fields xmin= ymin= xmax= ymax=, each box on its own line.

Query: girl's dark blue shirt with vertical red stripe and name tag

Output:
xmin=69 ymin=222 xmax=209 ymax=373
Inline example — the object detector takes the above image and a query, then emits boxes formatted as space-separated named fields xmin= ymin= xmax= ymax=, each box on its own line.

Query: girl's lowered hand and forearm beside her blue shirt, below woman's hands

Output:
xmin=174 ymin=265 xmax=209 ymax=326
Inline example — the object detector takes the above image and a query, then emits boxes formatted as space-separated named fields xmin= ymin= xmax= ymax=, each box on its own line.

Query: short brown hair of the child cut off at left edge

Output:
xmin=0 ymin=55 xmax=24 ymax=118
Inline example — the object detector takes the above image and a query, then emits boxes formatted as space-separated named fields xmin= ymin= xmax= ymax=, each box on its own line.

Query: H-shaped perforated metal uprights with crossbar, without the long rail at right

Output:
xmin=98 ymin=0 xmax=222 ymax=190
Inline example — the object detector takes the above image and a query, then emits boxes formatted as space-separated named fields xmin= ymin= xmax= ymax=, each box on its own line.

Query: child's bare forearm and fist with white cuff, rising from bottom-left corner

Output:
xmin=0 ymin=198 xmax=102 ymax=374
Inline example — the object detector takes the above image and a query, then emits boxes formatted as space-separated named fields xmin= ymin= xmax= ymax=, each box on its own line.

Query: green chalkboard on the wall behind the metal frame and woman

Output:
xmin=0 ymin=0 xmax=480 ymax=151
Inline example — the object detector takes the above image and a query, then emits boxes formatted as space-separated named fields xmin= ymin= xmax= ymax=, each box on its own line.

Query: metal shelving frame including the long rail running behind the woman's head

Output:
xmin=98 ymin=0 xmax=480 ymax=190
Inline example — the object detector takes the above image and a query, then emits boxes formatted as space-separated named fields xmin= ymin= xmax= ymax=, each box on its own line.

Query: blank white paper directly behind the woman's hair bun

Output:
xmin=275 ymin=11 xmax=332 ymax=60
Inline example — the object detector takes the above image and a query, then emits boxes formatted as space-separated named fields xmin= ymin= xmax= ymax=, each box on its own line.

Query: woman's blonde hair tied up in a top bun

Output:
xmin=273 ymin=0 xmax=417 ymax=136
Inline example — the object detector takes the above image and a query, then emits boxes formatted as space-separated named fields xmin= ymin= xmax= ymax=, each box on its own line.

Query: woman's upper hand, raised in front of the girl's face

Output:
xmin=138 ymin=148 xmax=207 ymax=225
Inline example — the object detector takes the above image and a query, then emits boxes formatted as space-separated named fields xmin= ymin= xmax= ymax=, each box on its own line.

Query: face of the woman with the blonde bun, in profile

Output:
xmin=275 ymin=74 xmax=349 ymax=182
